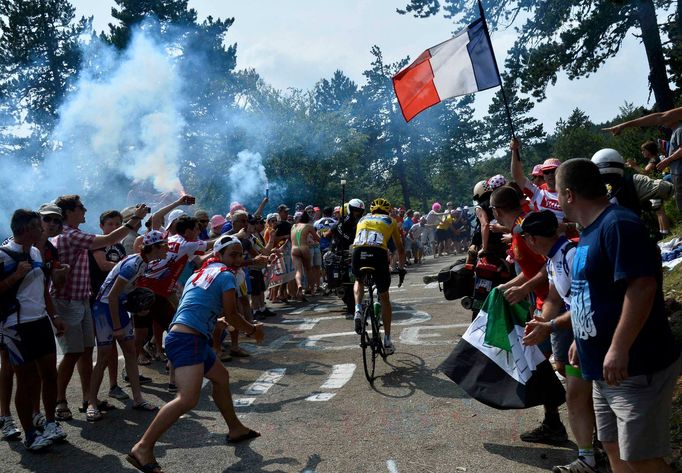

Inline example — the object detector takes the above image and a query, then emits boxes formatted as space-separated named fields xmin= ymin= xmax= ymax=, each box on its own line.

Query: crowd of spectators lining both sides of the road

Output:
xmin=0 ymin=109 xmax=682 ymax=473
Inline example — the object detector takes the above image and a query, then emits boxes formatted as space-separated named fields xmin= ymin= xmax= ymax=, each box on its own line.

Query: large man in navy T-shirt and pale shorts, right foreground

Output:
xmin=557 ymin=159 xmax=680 ymax=473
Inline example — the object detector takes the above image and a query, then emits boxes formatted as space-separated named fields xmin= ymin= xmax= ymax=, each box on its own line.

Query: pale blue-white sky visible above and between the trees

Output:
xmin=71 ymin=0 xmax=653 ymax=131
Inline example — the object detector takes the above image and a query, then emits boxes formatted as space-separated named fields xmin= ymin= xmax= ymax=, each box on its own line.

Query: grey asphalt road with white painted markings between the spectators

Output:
xmin=0 ymin=257 xmax=575 ymax=473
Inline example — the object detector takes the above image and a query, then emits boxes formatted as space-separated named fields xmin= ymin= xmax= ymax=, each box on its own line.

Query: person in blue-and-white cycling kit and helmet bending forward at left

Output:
xmin=86 ymin=230 xmax=168 ymax=422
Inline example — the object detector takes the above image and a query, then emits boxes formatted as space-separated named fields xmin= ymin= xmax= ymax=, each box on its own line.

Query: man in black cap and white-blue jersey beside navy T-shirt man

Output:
xmin=516 ymin=210 xmax=597 ymax=473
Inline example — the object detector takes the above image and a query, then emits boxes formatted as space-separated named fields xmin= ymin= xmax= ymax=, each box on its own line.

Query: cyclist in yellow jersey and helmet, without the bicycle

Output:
xmin=352 ymin=198 xmax=405 ymax=355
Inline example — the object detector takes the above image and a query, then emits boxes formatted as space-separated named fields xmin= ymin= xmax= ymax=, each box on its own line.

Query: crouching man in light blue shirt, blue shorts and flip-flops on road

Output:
xmin=126 ymin=235 xmax=264 ymax=472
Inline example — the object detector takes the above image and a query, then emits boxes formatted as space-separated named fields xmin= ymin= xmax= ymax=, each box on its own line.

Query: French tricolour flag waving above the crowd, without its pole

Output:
xmin=393 ymin=18 xmax=500 ymax=122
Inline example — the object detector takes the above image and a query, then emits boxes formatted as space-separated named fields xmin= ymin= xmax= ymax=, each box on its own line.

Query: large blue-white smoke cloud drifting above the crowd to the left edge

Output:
xmin=0 ymin=31 xmax=186 ymax=236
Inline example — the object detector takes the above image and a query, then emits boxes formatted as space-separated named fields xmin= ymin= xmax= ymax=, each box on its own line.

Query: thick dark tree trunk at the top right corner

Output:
xmin=634 ymin=0 xmax=674 ymax=112
